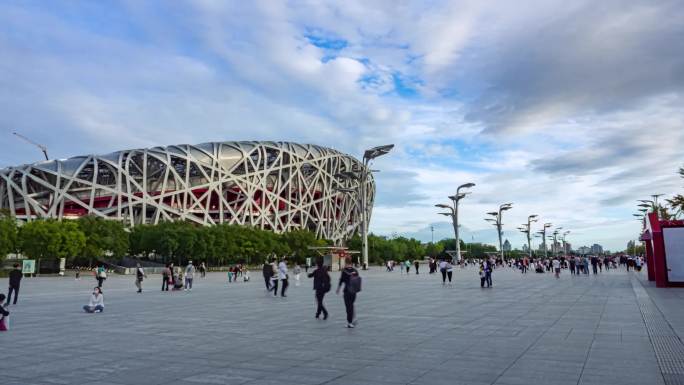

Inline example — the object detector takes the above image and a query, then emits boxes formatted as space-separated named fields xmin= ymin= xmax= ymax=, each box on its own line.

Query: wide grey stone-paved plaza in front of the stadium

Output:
xmin=0 ymin=268 xmax=684 ymax=385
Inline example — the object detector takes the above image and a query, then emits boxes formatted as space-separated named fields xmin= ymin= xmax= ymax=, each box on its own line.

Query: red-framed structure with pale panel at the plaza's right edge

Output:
xmin=640 ymin=213 xmax=684 ymax=287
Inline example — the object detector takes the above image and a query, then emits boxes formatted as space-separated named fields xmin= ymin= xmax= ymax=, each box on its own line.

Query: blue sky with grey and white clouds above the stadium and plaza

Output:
xmin=0 ymin=0 xmax=684 ymax=251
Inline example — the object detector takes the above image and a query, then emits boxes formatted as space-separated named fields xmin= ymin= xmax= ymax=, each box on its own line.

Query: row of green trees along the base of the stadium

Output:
xmin=0 ymin=213 xmax=496 ymax=266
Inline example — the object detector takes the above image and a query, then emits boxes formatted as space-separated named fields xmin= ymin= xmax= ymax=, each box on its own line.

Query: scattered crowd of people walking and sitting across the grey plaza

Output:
xmin=0 ymin=249 xmax=644 ymax=331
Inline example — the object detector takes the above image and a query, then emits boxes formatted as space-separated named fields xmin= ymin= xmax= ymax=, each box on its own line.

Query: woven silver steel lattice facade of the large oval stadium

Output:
xmin=0 ymin=142 xmax=375 ymax=240
